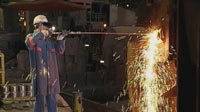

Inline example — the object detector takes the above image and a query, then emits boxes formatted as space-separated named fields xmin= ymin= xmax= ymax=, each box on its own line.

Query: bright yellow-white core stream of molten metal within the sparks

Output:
xmin=144 ymin=30 xmax=161 ymax=112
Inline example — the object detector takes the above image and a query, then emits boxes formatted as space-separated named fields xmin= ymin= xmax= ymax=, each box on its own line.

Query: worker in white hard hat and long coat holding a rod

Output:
xmin=25 ymin=15 xmax=68 ymax=112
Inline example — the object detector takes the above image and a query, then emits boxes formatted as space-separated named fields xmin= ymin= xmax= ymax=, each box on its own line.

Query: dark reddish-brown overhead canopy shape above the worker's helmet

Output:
xmin=3 ymin=0 xmax=86 ymax=12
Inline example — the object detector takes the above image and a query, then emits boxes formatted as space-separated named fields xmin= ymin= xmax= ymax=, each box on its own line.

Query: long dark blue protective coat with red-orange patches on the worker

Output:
xmin=25 ymin=30 xmax=65 ymax=95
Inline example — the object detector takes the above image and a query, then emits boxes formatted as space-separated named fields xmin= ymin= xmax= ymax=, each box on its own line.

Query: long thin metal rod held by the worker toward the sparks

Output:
xmin=52 ymin=31 xmax=145 ymax=36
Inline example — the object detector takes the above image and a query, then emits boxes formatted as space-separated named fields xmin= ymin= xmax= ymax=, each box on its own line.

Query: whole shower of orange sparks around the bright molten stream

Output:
xmin=127 ymin=30 xmax=176 ymax=112
